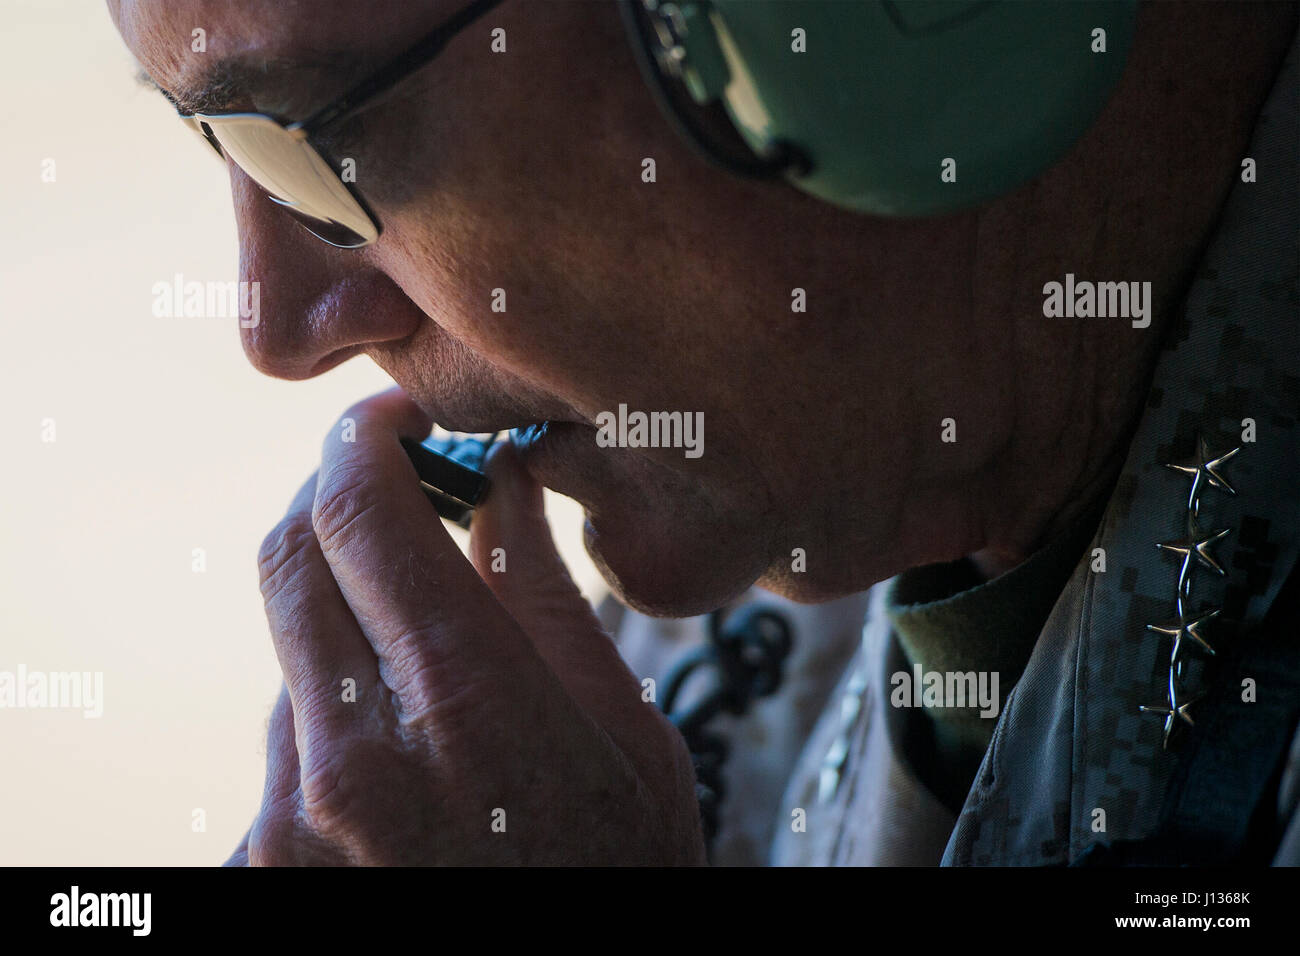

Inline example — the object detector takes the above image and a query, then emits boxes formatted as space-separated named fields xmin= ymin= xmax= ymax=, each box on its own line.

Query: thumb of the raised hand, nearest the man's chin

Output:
xmin=469 ymin=442 xmax=641 ymax=723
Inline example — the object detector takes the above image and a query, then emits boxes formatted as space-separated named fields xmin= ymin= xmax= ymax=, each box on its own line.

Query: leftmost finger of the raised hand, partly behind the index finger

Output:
xmin=257 ymin=476 xmax=382 ymax=745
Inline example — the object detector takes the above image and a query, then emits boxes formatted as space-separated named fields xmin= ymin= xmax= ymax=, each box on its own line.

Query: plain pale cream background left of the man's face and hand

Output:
xmin=0 ymin=0 xmax=601 ymax=865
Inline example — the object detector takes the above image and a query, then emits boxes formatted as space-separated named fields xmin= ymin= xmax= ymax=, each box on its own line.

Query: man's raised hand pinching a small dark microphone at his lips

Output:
xmin=231 ymin=390 xmax=703 ymax=865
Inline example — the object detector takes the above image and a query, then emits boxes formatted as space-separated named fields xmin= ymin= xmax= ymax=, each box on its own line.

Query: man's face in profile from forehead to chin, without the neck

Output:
xmin=111 ymin=0 xmax=904 ymax=614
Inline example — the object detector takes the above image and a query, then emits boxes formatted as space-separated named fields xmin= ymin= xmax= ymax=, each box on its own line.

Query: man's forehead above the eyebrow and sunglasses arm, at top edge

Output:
xmin=108 ymin=0 xmax=441 ymax=109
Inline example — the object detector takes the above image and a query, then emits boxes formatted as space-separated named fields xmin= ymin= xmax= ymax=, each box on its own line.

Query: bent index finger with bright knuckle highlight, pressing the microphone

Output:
xmin=312 ymin=390 xmax=545 ymax=713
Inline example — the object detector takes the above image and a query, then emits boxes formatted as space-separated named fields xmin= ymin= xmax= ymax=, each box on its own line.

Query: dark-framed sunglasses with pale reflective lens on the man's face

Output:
xmin=181 ymin=0 xmax=502 ymax=248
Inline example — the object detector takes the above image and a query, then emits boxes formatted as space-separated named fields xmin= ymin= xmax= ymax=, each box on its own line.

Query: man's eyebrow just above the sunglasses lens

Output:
xmin=135 ymin=51 xmax=374 ymax=118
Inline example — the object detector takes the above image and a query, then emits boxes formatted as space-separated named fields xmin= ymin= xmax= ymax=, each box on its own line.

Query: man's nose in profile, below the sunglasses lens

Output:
xmin=230 ymin=164 xmax=424 ymax=380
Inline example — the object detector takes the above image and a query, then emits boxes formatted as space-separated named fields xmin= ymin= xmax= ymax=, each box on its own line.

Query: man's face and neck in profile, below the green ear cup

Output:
xmin=109 ymin=0 xmax=1295 ymax=615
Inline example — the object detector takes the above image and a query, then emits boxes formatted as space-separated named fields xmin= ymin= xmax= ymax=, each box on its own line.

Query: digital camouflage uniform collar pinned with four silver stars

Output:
xmin=944 ymin=27 xmax=1300 ymax=864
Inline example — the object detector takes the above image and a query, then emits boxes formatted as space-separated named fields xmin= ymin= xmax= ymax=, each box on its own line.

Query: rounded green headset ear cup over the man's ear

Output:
xmin=681 ymin=0 xmax=1136 ymax=216
